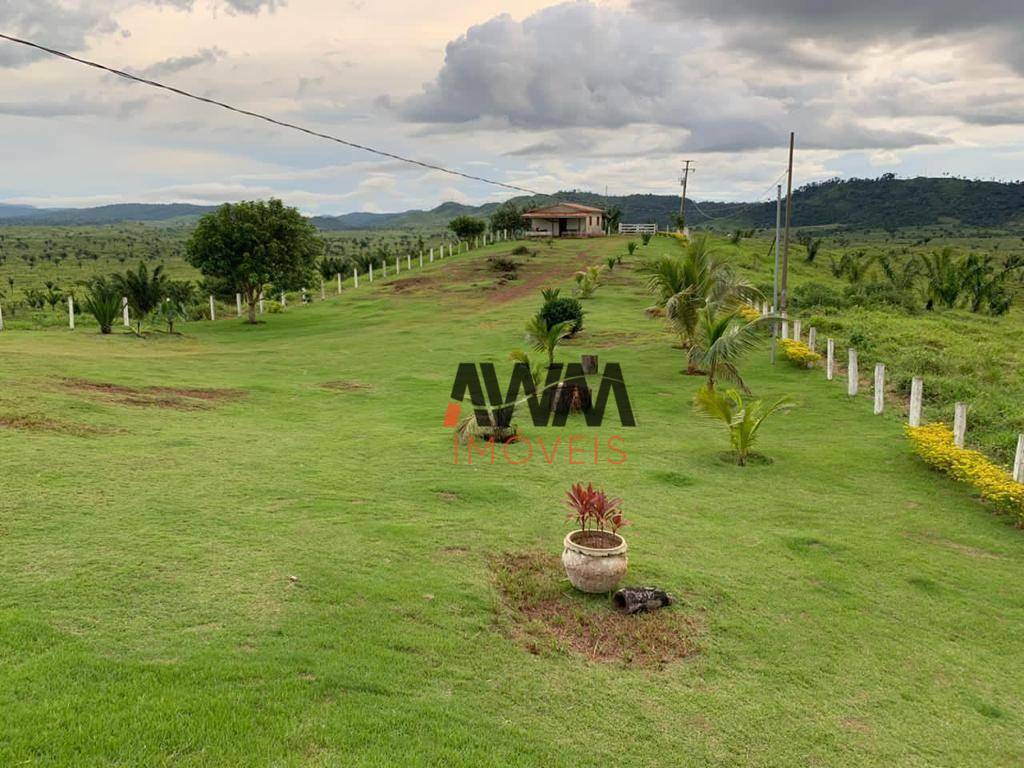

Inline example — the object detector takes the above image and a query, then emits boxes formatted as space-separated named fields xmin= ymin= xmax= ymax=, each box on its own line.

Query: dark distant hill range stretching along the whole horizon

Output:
xmin=0 ymin=174 xmax=1024 ymax=231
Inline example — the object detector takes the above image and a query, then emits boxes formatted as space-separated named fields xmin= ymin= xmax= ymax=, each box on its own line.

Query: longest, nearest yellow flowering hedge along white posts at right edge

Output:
xmin=906 ymin=423 xmax=1024 ymax=524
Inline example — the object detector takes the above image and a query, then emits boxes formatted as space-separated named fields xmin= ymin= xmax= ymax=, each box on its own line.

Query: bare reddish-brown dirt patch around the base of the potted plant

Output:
xmin=493 ymin=552 xmax=702 ymax=668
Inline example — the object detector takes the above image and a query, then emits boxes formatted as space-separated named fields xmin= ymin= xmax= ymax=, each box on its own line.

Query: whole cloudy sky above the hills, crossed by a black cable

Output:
xmin=0 ymin=0 xmax=1024 ymax=213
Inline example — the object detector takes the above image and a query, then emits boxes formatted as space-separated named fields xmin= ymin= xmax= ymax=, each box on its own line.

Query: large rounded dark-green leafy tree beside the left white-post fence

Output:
xmin=186 ymin=199 xmax=324 ymax=324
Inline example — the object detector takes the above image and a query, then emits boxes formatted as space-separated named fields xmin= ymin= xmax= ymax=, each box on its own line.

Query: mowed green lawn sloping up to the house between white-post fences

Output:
xmin=0 ymin=239 xmax=1024 ymax=766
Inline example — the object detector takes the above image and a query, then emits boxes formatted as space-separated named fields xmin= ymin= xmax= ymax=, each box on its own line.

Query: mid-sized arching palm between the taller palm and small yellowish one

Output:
xmin=689 ymin=305 xmax=778 ymax=394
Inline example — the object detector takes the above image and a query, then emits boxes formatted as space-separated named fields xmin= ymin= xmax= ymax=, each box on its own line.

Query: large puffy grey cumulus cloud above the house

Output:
xmin=394 ymin=2 xmax=941 ymax=156
